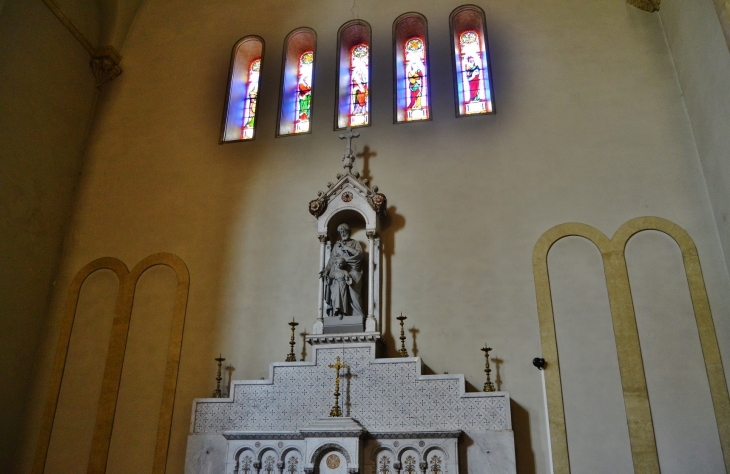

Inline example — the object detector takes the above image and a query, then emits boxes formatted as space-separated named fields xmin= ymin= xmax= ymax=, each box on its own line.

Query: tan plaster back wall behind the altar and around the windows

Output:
xmin=19 ymin=0 xmax=730 ymax=474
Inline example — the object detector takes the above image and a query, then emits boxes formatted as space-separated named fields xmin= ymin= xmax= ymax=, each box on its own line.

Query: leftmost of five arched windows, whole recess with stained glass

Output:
xmin=221 ymin=36 xmax=264 ymax=142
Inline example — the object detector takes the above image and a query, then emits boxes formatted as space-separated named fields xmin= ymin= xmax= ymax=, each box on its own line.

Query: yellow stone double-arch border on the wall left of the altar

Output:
xmin=33 ymin=252 xmax=190 ymax=474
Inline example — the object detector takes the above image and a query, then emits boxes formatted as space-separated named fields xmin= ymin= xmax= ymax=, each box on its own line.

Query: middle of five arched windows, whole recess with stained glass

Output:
xmin=335 ymin=20 xmax=371 ymax=130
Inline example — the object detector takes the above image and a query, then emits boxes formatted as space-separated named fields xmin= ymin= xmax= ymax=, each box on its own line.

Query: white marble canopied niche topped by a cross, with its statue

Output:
xmin=309 ymin=128 xmax=388 ymax=335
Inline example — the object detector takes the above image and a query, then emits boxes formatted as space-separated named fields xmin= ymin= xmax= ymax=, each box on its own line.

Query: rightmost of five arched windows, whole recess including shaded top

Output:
xmin=449 ymin=5 xmax=494 ymax=117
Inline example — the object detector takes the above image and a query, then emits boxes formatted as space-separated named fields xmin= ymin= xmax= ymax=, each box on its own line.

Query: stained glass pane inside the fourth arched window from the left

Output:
xmin=403 ymin=37 xmax=428 ymax=121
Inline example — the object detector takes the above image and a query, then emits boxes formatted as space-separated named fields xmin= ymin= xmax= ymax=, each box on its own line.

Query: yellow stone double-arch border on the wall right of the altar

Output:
xmin=532 ymin=217 xmax=730 ymax=474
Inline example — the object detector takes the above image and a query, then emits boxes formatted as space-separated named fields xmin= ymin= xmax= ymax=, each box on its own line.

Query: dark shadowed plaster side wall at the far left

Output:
xmin=0 ymin=0 xmax=96 ymax=469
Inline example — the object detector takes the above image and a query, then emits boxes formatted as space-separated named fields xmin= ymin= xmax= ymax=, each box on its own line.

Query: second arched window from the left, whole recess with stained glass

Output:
xmin=277 ymin=28 xmax=317 ymax=136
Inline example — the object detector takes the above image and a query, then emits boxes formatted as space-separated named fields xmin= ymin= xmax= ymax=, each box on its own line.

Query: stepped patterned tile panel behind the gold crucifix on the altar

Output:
xmin=193 ymin=345 xmax=511 ymax=434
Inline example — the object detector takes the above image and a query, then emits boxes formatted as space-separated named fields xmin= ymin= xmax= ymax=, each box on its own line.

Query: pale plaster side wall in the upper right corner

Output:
xmin=659 ymin=0 xmax=730 ymax=278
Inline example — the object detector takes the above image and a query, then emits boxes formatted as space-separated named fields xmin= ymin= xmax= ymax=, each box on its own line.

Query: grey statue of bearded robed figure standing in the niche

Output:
xmin=319 ymin=224 xmax=364 ymax=319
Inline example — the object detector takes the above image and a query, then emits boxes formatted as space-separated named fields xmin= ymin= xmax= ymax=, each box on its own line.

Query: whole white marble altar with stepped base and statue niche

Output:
xmin=185 ymin=130 xmax=516 ymax=474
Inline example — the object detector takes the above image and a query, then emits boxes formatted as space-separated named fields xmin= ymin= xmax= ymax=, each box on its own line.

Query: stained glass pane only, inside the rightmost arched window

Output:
xmin=458 ymin=30 xmax=492 ymax=114
